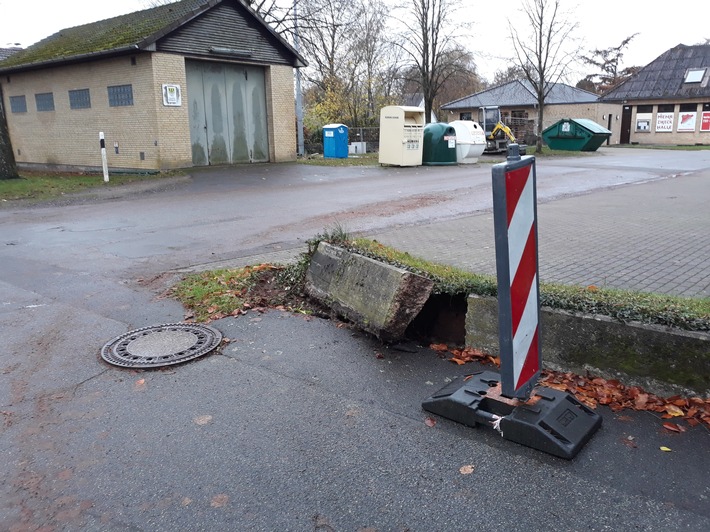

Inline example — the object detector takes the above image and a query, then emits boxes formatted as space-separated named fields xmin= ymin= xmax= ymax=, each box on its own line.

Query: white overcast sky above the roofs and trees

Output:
xmin=0 ymin=0 xmax=710 ymax=84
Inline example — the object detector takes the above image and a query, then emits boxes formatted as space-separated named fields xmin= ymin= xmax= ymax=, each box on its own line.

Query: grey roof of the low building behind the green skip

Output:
xmin=441 ymin=80 xmax=598 ymax=110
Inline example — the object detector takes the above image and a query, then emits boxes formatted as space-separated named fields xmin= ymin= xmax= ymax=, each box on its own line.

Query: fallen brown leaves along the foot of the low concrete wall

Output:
xmin=429 ymin=344 xmax=710 ymax=433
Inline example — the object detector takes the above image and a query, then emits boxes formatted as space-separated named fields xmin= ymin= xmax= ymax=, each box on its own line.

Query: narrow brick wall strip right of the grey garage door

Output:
xmin=266 ymin=65 xmax=296 ymax=162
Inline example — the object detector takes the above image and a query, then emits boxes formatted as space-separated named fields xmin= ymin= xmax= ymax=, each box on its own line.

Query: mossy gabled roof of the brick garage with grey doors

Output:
xmin=0 ymin=0 xmax=305 ymax=72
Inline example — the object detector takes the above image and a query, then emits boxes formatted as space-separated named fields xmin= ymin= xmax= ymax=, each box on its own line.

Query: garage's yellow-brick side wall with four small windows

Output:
xmin=3 ymin=53 xmax=168 ymax=169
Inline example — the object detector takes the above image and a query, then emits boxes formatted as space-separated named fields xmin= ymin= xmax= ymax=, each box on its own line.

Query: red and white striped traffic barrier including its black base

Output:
xmin=422 ymin=144 xmax=602 ymax=459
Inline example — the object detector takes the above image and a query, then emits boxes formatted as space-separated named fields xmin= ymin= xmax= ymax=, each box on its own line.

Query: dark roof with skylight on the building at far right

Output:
xmin=601 ymin=44 xmax=710 ymax=101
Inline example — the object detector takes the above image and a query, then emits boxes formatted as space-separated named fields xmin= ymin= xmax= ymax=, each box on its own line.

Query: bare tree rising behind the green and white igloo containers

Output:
xmin=397 ymin=0 xmax=470 ymax=122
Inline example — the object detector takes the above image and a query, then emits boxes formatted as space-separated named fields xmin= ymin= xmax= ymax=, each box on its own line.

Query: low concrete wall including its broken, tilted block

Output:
xmin=307 ymin=243 xmax=710 ymax=396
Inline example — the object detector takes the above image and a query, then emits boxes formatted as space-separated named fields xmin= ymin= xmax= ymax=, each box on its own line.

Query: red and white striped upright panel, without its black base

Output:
xmin=492 ymin=145 xmax=542 ymax=399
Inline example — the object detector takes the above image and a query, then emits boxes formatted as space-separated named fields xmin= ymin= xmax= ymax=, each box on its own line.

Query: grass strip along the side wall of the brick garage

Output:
xmin=0 ymin=172 xmax=174 ymax=202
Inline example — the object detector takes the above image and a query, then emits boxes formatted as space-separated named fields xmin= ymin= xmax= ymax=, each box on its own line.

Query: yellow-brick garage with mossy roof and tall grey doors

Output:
xmin=0 ymin=0 xmax=305 ymax=170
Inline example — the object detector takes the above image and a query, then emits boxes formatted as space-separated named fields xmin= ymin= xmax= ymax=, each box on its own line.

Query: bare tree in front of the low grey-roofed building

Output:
xmin=508 ymin=0 xmax=578 ymax=153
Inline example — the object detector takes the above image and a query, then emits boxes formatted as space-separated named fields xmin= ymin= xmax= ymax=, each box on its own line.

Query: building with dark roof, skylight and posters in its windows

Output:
xmin=601 ymin=44 xmax=710 ymax=145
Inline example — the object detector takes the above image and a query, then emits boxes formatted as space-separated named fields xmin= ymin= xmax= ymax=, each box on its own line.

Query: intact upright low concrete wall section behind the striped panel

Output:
xmin=466 ymin=296 xmax=710 ymax=396
